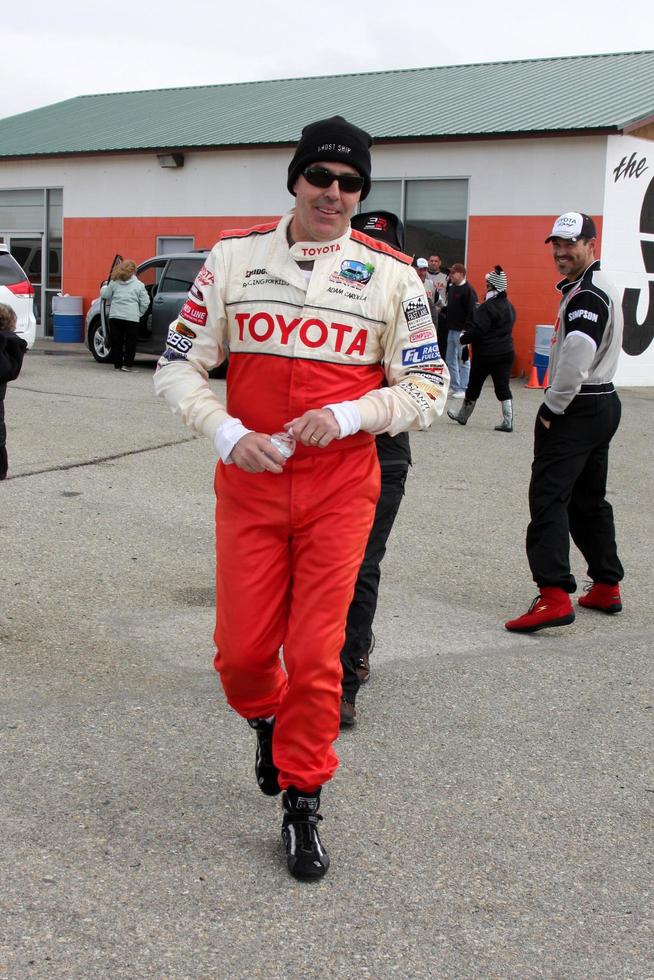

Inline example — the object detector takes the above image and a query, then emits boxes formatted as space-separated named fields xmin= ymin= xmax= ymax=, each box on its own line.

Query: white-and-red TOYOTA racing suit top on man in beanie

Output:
xmin=154 ymin=212 xmax=449 ymax=459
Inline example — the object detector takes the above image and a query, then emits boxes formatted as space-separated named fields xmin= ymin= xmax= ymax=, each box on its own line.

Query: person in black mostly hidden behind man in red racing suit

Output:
xmin=341 ymin=211 xmax=411 ymax=727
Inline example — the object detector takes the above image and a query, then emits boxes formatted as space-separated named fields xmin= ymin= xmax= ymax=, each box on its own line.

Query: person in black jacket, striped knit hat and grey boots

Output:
xmin=447 ymin=265 xmax=515 ymax=432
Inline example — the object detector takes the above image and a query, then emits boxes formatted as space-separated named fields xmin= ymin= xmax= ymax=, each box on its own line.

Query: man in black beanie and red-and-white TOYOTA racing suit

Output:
xmin=155 ymin=116 xmax=448 ymax=878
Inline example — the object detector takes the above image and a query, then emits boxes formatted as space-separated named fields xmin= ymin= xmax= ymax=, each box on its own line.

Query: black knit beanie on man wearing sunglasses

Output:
xmin=286 ymin=116 xmax=372 ymax=201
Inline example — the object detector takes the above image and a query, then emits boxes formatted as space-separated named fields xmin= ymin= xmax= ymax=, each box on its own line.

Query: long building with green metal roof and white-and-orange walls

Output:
xmin=0 ymin=51 xmax=654 ymax=377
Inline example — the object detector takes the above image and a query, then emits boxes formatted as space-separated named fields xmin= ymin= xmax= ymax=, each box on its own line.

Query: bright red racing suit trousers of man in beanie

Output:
xmin=214 ymin=439 xmax=380 ymax=791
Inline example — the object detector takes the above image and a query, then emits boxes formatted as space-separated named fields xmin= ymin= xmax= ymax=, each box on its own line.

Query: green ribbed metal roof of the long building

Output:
xmin=0 ymin=51 xmax=654 ymax=158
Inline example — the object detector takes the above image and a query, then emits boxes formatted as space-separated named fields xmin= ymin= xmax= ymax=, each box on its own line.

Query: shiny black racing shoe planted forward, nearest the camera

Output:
xmin=282 ymin=786 xmax=329 ymax=881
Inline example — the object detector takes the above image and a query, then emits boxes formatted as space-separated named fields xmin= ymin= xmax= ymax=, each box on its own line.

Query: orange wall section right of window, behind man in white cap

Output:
xmin=468 ymin=214 xmax=602 ymax=375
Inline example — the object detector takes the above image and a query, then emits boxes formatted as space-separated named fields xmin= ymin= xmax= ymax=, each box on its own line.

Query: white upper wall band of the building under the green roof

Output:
xmin=0 ymin=137 xmax=606 ymax=217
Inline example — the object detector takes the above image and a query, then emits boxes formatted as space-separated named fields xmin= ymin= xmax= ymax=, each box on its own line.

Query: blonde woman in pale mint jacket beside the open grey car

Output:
xmin=100 ymin=259 xmax=150 ymax=371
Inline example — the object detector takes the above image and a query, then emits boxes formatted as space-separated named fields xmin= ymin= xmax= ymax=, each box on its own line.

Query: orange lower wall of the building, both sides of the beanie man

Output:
xmin=63 ymin=215 xmax=602 ymax=375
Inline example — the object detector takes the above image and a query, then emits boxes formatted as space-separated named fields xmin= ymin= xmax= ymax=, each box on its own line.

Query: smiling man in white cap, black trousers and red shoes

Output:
xmin=505 ymin=211 xmax=624 ymax=633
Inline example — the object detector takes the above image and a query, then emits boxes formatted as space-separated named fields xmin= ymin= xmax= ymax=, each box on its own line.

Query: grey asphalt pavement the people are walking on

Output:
xmin=0 ymin=341 xmax=654 ymax=980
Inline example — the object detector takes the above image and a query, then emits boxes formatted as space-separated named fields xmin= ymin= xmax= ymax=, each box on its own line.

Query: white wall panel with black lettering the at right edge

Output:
xmin=601 ymin=136 xmax=654 ymax=385
